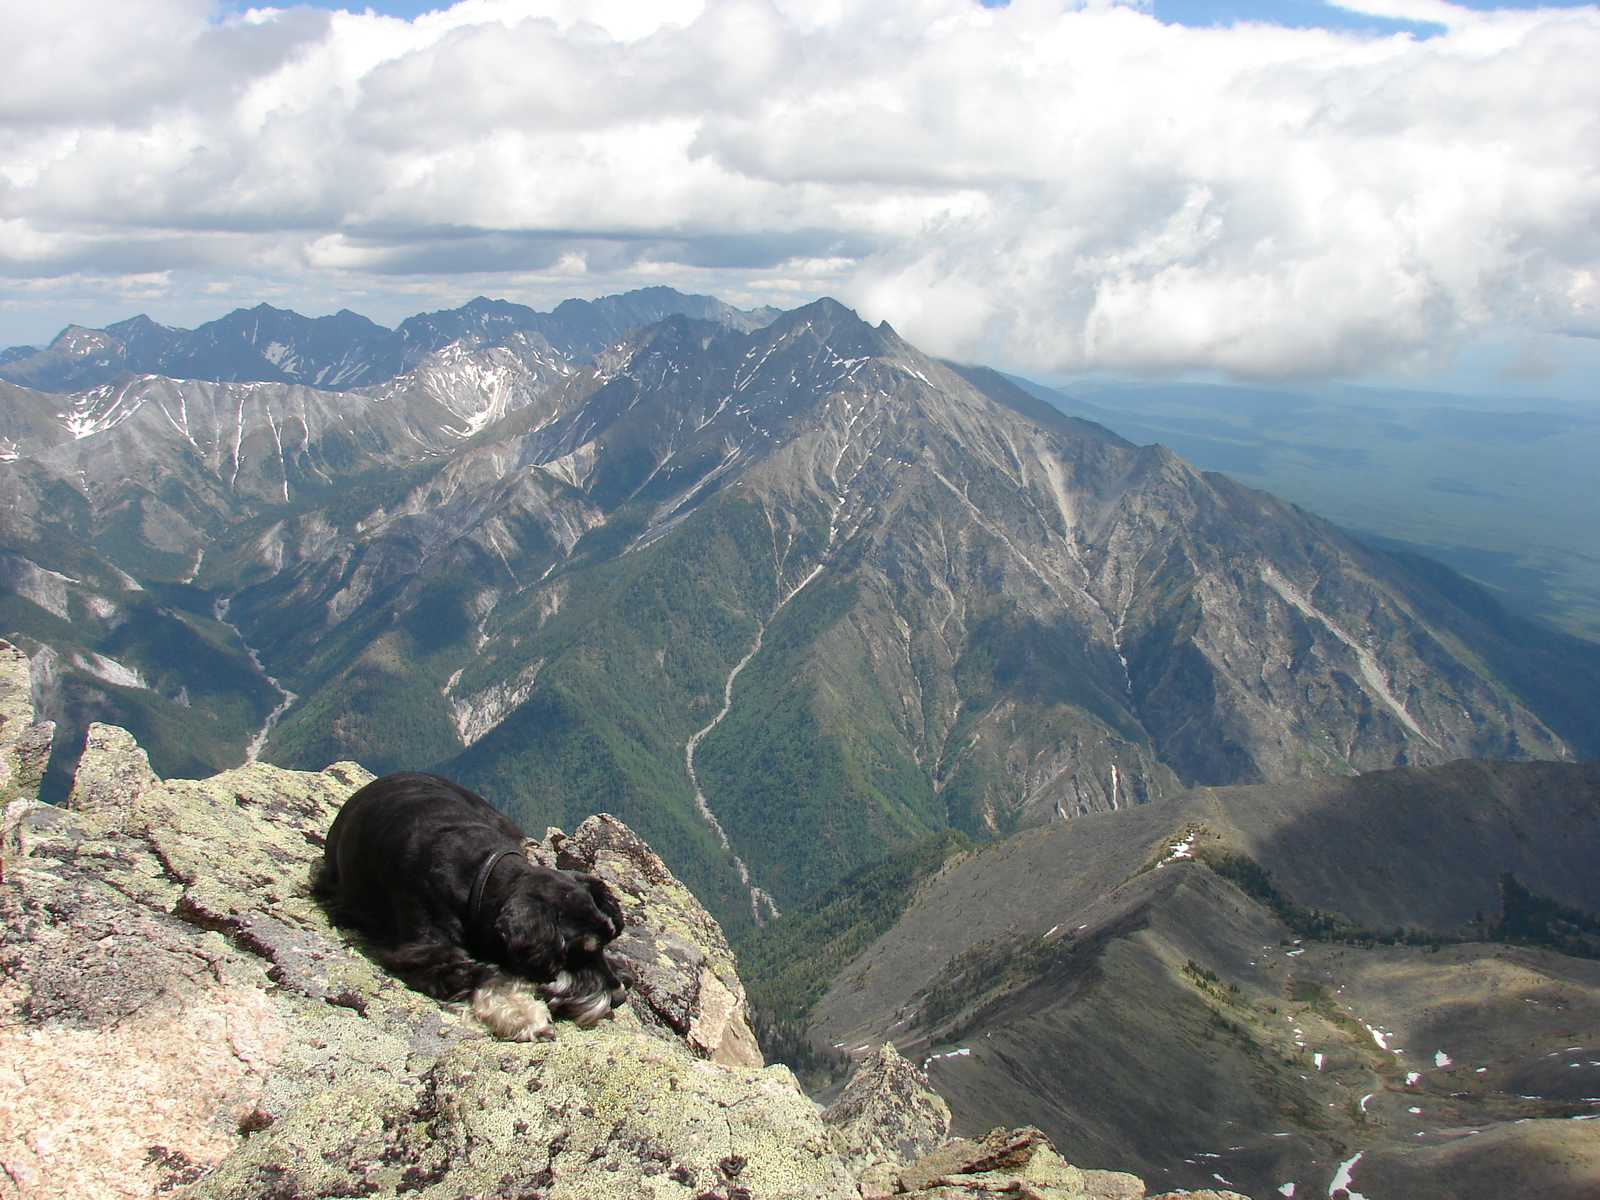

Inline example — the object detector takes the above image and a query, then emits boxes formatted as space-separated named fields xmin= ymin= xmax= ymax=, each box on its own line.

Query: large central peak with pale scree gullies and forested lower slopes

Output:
xmin=184 ymin=302 xmax=1582 ymax=920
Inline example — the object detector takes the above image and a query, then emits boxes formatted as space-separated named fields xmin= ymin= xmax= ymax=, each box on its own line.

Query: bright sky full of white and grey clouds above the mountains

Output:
xmin=0 ymin=0 xmax=1600 ymax=402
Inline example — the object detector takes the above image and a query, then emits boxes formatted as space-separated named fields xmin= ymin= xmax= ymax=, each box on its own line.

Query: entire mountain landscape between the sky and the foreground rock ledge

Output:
xmin=0 ymin=290 xmax=1600 ymax=1200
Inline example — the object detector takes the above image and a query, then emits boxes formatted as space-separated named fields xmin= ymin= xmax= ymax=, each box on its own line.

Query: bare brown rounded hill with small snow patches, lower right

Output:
xmin=806 ymin=762 xmax=1600 ymax=1200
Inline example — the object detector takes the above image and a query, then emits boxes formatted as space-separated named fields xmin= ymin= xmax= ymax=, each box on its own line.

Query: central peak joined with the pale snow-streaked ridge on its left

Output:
xmin=0 ymin=301 xmax=1600 ymax=928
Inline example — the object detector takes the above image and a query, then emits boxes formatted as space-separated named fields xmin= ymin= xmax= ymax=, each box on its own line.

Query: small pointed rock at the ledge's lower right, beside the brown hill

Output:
xmin=822 ymin=1043 xmax=950 ymax=1187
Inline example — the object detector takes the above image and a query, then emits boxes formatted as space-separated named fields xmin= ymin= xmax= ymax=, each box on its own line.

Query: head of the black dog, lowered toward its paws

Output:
xmin=494 ymin=867 xmax=632 ymax=1027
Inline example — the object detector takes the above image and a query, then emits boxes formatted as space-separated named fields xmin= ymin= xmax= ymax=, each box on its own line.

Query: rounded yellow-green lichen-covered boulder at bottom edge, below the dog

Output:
xmin=190 ymin=1027 xmax=858 ymax=1200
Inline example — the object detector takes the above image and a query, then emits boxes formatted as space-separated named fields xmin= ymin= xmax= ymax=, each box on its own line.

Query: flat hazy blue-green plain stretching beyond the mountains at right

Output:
xmin=998 ymin=382 xmax=1600 ymax=640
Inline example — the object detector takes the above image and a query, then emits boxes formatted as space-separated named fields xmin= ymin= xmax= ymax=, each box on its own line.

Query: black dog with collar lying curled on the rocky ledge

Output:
xmin=312 ymin=771 xmax=624 ymax=1042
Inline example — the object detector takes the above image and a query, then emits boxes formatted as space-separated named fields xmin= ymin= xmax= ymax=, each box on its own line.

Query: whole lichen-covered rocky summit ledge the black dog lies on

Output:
xmin=0 ymin=643 xmax=1221 ymax=1200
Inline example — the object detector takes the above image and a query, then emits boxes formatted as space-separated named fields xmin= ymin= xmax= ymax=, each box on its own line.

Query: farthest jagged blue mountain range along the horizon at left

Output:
xmin=0 ymin=288 xmax=776 ymax=392
